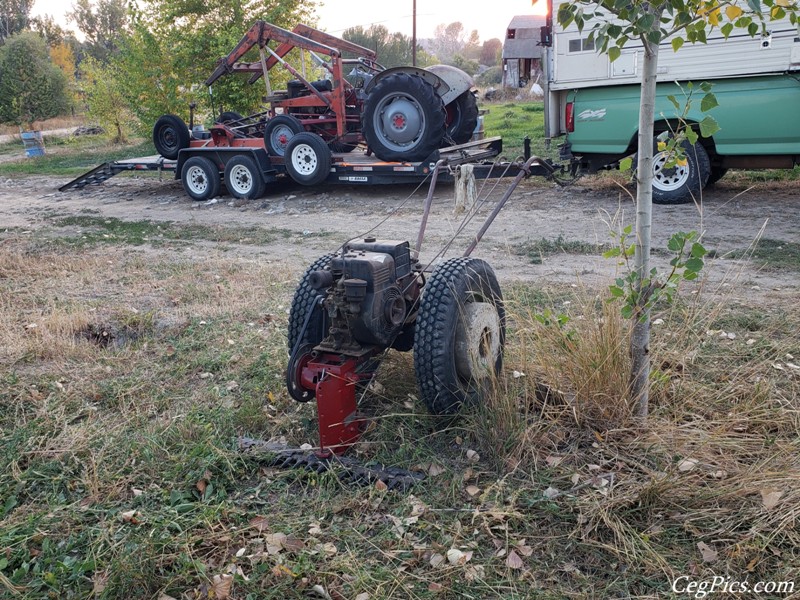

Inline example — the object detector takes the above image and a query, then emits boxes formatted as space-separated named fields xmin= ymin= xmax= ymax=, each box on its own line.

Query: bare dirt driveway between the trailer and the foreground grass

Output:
xmin=0 ymin=171 xmax=800 ymax=299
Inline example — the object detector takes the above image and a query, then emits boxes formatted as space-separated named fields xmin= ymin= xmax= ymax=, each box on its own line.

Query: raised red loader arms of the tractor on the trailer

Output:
xmin=205 ymin=21 xmax=340 ymax=86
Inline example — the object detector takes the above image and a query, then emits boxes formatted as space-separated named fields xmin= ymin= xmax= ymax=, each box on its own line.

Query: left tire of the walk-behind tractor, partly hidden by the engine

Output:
xmin=286 ymin=254 xmax=332 ymax=402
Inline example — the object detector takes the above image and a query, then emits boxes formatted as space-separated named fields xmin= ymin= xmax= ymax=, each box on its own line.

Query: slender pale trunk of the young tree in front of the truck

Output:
xmin=630 ymin=36 xmax=660 ymax=420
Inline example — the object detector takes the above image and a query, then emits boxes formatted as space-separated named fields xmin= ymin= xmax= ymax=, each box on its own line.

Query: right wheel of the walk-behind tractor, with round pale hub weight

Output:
xmin=414 ymin=257 xmax=505 ymax=415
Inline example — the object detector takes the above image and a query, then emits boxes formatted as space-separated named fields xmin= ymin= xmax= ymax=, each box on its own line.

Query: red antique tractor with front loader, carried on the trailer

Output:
xmin=153 ymin=21 xmax=478 ymax=177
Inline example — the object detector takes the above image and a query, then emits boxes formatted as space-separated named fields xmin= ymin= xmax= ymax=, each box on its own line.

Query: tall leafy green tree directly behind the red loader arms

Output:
xmin=115 ymin=0 xmax=314 ymax=130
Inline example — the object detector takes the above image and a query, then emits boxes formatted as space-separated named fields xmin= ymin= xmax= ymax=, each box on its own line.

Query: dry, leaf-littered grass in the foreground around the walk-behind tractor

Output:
xmin=0 ymin=227 xmax=800 ymax=599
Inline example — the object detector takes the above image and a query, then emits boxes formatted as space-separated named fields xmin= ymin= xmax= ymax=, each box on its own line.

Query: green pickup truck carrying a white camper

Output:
xmin=541 ymin=0 xmax=800 ymax=204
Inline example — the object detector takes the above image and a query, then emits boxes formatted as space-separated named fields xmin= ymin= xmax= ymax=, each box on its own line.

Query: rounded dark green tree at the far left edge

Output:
xmin=0 ymin=31 xmax=68 ymax=129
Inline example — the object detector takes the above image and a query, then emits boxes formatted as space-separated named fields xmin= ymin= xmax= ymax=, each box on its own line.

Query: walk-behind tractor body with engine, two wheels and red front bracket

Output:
xmin=287 ymin=237 xmax=505 ymax=456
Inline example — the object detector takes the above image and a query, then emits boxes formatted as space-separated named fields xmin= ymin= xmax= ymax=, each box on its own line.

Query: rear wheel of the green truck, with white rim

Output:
xmin=653 ymin=140 xmax=711 ymax=204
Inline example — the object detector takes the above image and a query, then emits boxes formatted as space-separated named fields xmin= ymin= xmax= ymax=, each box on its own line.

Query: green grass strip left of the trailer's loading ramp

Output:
xmin=0 ymin=136 xmax=156 ymax=176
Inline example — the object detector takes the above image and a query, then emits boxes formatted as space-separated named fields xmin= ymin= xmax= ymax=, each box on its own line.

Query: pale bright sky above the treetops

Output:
xmin=31 ymin=0 xmax=544 ymax=41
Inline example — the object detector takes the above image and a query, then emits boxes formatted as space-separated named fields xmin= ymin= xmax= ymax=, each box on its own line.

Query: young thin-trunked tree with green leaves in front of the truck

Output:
xmin=557 ymin=0 xmax=797 ymax=419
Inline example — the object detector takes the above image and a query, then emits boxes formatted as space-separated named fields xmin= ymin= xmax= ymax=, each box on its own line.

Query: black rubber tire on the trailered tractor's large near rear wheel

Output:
xmin=361 ymin=73 xmax=447 ymax=161
